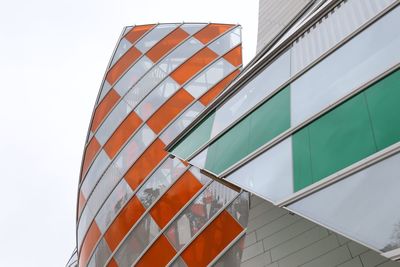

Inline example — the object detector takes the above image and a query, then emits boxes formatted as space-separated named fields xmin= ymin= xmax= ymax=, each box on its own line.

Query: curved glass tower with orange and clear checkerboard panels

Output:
xmin=77 ymin=23 xmax=248 ymax=266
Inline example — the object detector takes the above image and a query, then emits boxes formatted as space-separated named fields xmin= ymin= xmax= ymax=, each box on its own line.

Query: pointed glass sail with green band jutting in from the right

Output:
xmin=165 ymin=0 xmax=400 ymax=257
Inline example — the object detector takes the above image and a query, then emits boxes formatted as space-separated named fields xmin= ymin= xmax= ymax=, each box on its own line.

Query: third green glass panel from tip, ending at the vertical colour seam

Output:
xmin=249 ymin=87 xmax=290 ymax=152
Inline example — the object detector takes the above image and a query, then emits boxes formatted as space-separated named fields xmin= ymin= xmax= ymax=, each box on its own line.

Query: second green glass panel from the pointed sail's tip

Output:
xmin=205 ymin=119 xmax=250 ymax=174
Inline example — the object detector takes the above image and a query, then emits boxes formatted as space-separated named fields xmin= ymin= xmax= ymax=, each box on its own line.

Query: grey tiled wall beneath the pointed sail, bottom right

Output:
xmin=241 ymin=196 xmax=400 ymax=267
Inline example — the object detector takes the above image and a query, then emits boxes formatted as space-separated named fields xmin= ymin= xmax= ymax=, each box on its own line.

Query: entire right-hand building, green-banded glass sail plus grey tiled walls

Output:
xmin=167 ymin=0 xmax=400 ymax=267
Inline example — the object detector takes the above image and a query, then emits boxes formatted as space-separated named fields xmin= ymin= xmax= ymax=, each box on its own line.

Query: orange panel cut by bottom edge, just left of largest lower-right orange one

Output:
xmin=135 ymin=235 xmax=176 ymax=267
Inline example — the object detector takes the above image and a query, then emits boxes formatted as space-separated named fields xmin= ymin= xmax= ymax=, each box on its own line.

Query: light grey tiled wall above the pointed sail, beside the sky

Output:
xmin=257 ymin=0 xmax=310 ymax=52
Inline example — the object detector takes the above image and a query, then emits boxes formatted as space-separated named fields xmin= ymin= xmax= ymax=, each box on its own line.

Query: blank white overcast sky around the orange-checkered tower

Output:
xmin=0 ymin=0 xmax=258 ymax=267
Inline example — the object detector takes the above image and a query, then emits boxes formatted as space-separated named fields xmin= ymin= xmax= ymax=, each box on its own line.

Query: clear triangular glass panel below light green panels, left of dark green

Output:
xmin=226 ymin=138 xmax=293 ymax=202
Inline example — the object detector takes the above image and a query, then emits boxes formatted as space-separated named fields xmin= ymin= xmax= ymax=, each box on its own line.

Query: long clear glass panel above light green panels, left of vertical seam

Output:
xmin=211 ymin=49 xmax=290 ymax=138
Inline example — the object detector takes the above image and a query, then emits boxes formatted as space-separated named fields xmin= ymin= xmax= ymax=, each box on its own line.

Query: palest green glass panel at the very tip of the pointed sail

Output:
xmin=171 ymin=112 xmax=215 ymax=159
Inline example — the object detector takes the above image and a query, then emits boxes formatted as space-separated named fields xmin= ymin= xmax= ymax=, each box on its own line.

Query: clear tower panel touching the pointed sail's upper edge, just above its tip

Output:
xmin=160 ymin=102 xmax=204 ymax=144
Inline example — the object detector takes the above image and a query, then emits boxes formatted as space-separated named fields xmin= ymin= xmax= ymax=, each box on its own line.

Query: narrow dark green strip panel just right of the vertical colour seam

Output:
xmin=292 ymin=127 xmax=313 ymax=192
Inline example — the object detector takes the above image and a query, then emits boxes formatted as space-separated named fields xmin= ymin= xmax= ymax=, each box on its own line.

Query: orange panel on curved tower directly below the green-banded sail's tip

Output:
xmin=150 ymin=171 xmax=202 ymax=228
